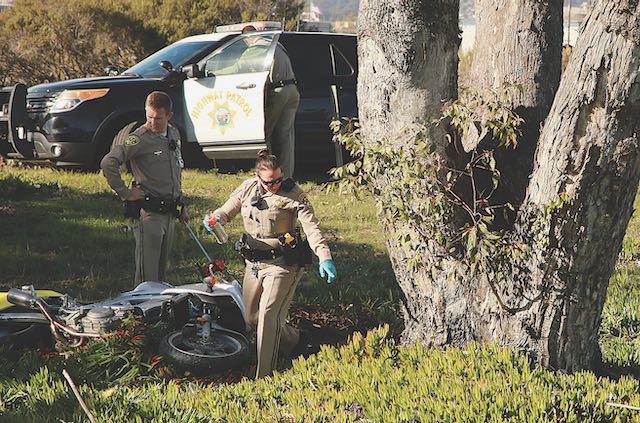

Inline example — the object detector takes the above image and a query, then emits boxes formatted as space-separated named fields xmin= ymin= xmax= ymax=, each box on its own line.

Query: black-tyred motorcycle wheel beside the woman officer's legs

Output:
xmin=158 ymin=331 xmax=249 ymax=373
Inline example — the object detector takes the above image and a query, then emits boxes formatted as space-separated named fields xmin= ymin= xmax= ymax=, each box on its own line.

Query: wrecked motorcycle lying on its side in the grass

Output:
xmin=0 ymin=260 xmax=249 ymax=373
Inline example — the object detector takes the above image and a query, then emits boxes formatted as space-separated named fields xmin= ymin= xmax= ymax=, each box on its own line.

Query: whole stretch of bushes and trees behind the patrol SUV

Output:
xmin=0 ymin=0 xmax=302 ymax=85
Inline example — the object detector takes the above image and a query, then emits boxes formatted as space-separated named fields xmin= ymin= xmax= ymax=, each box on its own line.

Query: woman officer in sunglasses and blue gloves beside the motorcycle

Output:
xmin=205 ymin=150 xmax=337 ymax=378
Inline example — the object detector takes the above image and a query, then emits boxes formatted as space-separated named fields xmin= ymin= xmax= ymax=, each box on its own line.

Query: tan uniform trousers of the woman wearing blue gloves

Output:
xmin=242 ymin=258 xmax=303 ymax=379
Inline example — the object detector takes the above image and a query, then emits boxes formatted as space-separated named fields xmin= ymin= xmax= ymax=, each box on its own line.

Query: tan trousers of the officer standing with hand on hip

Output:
xmin=133 ymin=209 xmax=176 ymax=284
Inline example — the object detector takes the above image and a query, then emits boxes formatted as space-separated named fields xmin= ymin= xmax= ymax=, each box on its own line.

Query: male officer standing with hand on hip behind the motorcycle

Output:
xmin=100 ymin=91 xmax=189 ymax=283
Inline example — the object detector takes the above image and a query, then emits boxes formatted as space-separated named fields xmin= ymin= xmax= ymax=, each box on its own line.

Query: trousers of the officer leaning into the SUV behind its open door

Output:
xmin=265 ymin=84 xmax=300 ymax=178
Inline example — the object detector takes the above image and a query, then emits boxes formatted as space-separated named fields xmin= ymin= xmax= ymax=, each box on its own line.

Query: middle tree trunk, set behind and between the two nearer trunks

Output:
xmin=471 ymin=0 xmax=563 ymax=207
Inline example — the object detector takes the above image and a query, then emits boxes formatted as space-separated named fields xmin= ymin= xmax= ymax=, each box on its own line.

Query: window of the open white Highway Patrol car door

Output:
xmin=204 ymin=34 xmax=274 ymax=76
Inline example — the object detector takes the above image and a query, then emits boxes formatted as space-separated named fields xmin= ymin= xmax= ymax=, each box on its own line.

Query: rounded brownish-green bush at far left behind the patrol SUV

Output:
xmin=0 ymin=0 xmax=163 ymax=84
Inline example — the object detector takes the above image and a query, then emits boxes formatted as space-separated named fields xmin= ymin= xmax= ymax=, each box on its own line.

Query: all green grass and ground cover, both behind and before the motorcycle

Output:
xmin=0 ymin=167 xmax=640 ymax=422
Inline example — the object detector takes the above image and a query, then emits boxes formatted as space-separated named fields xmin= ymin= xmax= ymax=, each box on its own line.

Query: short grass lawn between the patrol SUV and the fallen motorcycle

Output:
xmin=0 ymin=167 xmax=400 ymax=312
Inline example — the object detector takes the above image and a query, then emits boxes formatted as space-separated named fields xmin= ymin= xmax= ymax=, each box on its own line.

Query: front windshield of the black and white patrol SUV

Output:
xmin=123 ymin=41 xmax=216 ymax=78
